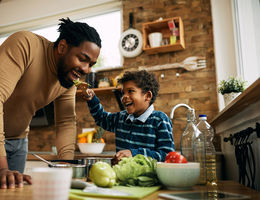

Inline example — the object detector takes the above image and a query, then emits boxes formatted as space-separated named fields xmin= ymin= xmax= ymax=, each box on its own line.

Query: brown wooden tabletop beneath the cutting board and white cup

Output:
xmin=0 ymin=181 xmax=260 ymax=200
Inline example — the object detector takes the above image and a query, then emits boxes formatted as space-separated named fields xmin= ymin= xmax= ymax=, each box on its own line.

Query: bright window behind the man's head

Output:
xmin=0 ymin=11 xmax=122 ymax=71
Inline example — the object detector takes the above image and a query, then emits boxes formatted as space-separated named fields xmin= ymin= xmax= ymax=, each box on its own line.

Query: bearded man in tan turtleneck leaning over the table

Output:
xmin=0 ymin=18 xmax=101 ymax=188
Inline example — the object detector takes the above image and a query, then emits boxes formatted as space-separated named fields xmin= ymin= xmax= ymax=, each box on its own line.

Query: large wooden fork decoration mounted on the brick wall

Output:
xmin=138 ymin=56 xmax=207 ymax=71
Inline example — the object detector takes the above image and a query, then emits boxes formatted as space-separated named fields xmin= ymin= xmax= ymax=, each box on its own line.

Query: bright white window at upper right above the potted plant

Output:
xmin=232 ymin=0 xmax=260 ymax=84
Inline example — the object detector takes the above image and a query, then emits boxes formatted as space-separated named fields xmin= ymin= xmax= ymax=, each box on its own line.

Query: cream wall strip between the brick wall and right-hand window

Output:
xmin=211 ymin=0 xmax=237 ymax=110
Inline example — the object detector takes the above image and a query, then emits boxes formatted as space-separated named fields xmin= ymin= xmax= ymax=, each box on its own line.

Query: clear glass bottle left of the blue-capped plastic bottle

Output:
xmin=181 ymin=109 xmax=206 ymax=184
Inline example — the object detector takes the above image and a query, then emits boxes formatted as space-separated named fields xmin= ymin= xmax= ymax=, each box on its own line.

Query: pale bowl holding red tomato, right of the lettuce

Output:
xmin=156 ymin=162 xmax=200 ymax=190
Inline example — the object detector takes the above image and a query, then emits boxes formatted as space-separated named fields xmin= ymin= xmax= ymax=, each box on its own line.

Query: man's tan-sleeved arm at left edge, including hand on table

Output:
xmin=0 ymin=32 xmax=35 ymax=188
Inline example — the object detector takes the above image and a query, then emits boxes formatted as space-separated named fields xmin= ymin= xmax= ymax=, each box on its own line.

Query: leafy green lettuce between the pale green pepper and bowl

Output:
xmin=113 ymin=154 xmax=158 ymax=187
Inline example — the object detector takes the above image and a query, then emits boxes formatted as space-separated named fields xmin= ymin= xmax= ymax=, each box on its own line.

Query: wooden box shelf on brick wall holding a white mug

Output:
xmin=143 ymin=17 xmax=185 ymax=54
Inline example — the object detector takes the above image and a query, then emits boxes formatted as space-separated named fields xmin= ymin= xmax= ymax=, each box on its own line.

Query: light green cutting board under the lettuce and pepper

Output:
xmin=70 ymin=186 xmax=161 ymax=200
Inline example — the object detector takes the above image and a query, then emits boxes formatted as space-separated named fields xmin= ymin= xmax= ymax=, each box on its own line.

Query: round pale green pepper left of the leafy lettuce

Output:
xmin=89 ymin=161 xmax=116 ymax=188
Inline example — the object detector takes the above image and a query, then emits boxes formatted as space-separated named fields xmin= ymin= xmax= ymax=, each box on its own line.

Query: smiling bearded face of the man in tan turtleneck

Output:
xmin=58 ymin=41 xmax=100 ymax=88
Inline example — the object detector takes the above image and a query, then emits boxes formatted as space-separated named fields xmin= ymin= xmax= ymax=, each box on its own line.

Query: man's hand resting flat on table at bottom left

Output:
xmin=0 ymin=168 xmax=32 ymax=189
